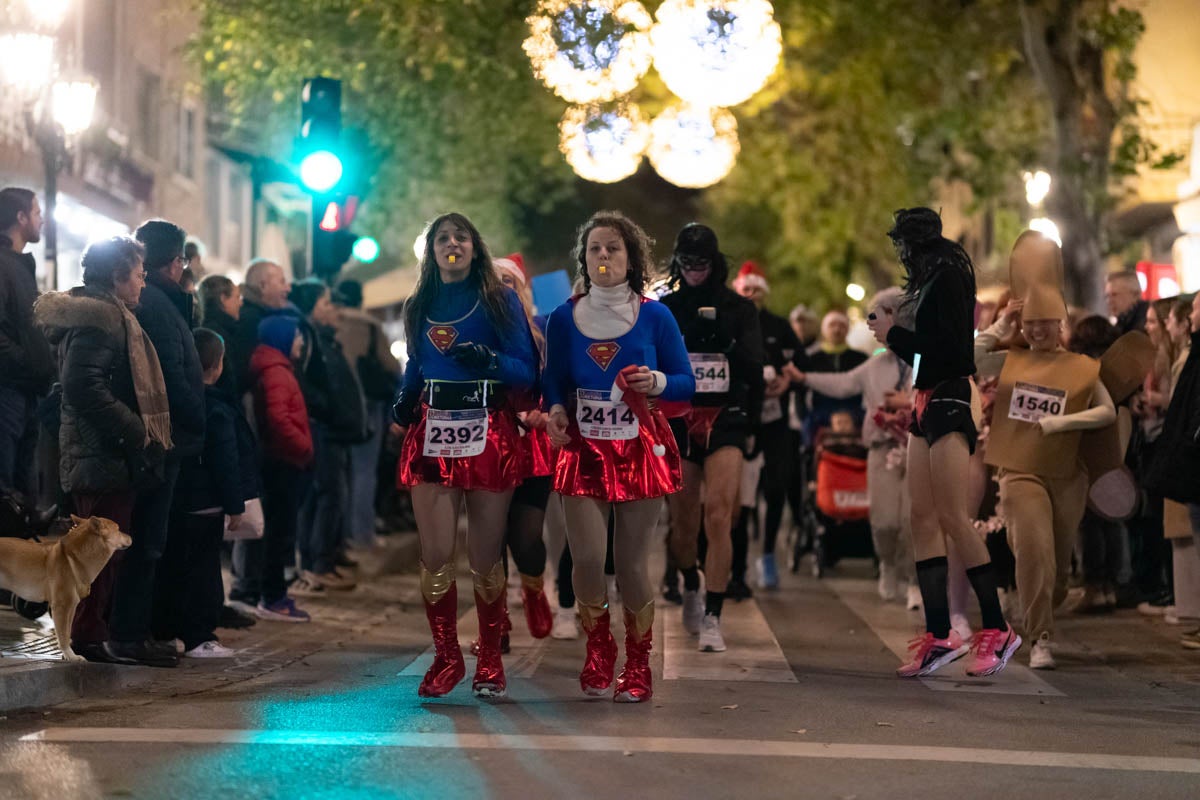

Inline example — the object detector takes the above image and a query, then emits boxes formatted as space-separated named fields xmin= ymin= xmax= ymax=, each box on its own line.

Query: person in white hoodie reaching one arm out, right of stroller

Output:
xmin=802 ymin=288 xmax=920 ymax=608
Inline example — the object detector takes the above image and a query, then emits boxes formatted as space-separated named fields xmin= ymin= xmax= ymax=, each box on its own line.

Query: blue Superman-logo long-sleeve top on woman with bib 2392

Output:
xmin=404 ymin=279 xmax=538 ymax=392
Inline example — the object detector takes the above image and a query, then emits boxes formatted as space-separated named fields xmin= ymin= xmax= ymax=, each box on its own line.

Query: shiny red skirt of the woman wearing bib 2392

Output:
xmin=396 ymin=403 xmax=529 ymax=492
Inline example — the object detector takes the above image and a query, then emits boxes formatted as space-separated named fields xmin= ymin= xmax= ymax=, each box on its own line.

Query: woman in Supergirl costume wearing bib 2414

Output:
xmin=542 ymin=211 xmax=696 ymax=703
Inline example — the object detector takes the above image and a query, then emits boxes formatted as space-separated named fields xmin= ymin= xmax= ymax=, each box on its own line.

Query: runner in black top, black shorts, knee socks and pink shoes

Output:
xmin=868 ymin=209 xmax=1021 ymax=678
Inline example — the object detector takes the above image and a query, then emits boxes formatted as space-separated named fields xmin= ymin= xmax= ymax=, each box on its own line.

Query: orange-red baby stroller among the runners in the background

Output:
xmin=793 ymin=431 xmax=875 ymax=578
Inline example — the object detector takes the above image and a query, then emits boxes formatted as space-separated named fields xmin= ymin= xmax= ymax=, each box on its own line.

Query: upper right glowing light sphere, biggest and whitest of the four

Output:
xmin=650 ymin=0 xmax=784 ymax=107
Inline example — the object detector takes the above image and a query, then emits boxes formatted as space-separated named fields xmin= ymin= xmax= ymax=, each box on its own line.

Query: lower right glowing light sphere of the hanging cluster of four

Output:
xmin=647 ymin=106 xmax=742 ymax=188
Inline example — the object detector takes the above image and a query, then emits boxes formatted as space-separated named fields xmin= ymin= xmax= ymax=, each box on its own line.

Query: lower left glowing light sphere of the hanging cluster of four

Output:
xmin=558 ymin=103 xmax=650 ymax=184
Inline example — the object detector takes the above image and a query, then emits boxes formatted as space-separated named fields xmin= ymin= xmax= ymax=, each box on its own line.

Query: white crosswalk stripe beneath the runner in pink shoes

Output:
xmin=822 ymin=578 xmax=1066 ymax=697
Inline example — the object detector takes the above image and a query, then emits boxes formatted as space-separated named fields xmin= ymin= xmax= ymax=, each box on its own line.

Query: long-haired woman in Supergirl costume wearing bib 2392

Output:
xmin=392 ymin=213 xmax=538 ymax=697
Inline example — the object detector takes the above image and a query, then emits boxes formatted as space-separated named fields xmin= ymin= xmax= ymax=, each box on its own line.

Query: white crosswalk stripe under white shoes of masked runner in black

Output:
xmin=655 ymin=600 xmax=797 ymax=684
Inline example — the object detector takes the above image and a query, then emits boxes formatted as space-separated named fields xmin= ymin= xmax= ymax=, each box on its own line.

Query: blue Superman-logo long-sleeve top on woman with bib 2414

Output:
xmin=541 ymin=293 xmax=696 ymax=409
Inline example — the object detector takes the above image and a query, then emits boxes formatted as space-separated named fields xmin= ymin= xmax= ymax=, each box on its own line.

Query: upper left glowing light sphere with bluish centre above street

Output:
xmin=524 ymin=0 xmax=654 ymax=104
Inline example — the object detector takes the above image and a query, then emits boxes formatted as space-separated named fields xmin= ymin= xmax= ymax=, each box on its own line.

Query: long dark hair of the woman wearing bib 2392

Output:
xmin=404 ymin=212 xmax=516 ymax=345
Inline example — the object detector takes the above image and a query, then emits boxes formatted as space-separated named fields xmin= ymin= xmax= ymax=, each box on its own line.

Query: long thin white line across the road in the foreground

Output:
xmin=20 ymin=728 xmax=1200 ymax=775
